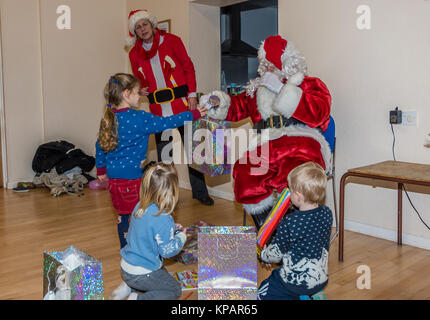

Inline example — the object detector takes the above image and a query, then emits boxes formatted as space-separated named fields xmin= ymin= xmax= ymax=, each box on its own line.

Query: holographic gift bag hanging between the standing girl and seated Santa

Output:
xmin=190 ymin=117 xmax=231 ymax=177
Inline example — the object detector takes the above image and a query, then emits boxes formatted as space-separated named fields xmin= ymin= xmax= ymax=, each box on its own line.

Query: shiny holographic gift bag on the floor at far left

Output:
xmin=43 ymin=246 xmax=104 ymax=300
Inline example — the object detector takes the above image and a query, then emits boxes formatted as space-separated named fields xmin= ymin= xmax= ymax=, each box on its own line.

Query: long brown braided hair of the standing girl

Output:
xmin=97 ymin=73 xmax=139 ymax=152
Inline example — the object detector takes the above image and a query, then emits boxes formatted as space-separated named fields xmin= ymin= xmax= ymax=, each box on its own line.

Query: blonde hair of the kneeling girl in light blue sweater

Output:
xmin=135 ymin=163 xmax=179 ymax=218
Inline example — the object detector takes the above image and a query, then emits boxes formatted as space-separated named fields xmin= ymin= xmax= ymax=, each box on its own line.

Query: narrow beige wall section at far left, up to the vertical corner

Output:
xmin=0 ymin=0 xmax=43 ymax=185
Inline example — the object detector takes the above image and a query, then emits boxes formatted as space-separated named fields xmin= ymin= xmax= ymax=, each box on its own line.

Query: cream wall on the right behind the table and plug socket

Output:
xmin=279 ymin=0 xmax=430 ymax=249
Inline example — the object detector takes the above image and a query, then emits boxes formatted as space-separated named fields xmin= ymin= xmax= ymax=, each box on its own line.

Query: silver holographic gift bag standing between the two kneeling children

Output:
xmin=198 ymin=227 xmax=257 ymax=300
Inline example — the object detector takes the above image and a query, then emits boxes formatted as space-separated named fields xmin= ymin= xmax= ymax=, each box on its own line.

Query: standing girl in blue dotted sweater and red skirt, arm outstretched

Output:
xmin=96 ymin=73 xmax=206 ymax=248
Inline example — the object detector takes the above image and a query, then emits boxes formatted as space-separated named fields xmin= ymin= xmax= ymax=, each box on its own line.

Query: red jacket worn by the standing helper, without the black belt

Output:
xmin=129 ymin=29 xmax=196 ymax=116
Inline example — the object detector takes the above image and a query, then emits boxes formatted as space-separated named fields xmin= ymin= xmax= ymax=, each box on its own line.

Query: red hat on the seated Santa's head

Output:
xmin=258 ymin=35 xmax=288 ymax=70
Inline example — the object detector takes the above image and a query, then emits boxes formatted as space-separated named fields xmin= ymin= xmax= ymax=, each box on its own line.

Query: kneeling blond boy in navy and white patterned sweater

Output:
xmin=258 ymin=162 xmax=333 ymax=300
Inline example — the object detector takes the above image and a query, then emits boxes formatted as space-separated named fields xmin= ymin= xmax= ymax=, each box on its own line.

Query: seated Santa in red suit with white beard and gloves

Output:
xmin=200 ymin=36 xmax=331 ymax=228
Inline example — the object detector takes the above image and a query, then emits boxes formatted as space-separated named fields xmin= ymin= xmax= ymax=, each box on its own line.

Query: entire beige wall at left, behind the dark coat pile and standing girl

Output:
xmin=0 ymin=0 xmax=127 ymax=188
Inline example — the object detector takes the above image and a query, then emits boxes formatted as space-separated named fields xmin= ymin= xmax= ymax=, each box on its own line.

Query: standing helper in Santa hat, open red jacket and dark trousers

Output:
xmin=127 ymin=10 xmax=214 ymax=205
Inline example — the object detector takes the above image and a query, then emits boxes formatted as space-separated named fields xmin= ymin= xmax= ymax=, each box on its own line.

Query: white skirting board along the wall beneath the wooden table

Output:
xmin=344 ymin=220 xmax=430 ymax=250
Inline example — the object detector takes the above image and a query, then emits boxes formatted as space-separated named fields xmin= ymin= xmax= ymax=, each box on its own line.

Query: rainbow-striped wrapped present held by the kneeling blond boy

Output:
xmin=257 ymin=188 xmax=291 ymax=255
